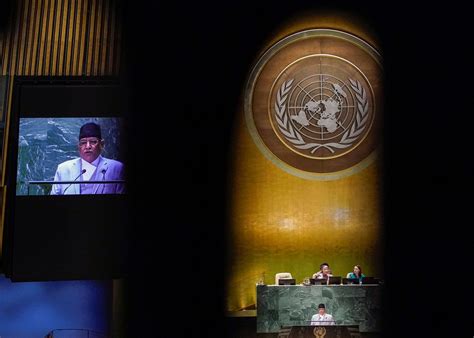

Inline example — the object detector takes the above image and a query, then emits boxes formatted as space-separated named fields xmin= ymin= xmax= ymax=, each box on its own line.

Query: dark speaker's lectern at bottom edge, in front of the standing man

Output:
xmin=278 ymin=325 xmax=360 ymax=338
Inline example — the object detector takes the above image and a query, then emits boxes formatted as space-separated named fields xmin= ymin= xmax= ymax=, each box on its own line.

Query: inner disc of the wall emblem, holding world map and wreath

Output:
xmin=270 ymin=55 xmax=374 ymax=159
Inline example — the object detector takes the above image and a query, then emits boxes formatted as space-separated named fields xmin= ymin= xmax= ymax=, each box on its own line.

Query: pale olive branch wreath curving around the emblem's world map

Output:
xmin=275 ymin=79 xmax=369 ymax=153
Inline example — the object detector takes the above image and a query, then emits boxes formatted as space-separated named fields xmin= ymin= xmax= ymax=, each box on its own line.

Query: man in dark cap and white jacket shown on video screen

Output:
xmin=51 ymin=122 xmax=124 ymax=195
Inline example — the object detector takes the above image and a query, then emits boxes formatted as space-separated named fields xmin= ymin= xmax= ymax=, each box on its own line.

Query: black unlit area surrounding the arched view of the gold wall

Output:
xmin=125 ymin=1 xmax=473 ymax=337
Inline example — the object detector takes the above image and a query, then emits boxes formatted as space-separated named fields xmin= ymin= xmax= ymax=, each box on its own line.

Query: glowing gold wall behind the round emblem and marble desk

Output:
xmin=226 ymin=17 xmax=384 ymax=311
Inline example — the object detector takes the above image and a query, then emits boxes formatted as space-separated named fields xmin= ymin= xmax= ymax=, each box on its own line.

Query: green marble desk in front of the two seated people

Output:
xmin=257 ymin=285 xmax=383 ymax=333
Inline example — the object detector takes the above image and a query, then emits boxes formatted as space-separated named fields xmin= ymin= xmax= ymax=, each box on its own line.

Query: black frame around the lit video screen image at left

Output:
xmin=2 ymin=76 xmax=129 ymax=281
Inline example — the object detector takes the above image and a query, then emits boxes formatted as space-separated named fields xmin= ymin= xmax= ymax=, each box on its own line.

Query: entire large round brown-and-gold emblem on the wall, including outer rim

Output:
xmin=245 ymin=29 xmax=382 ymax=180
